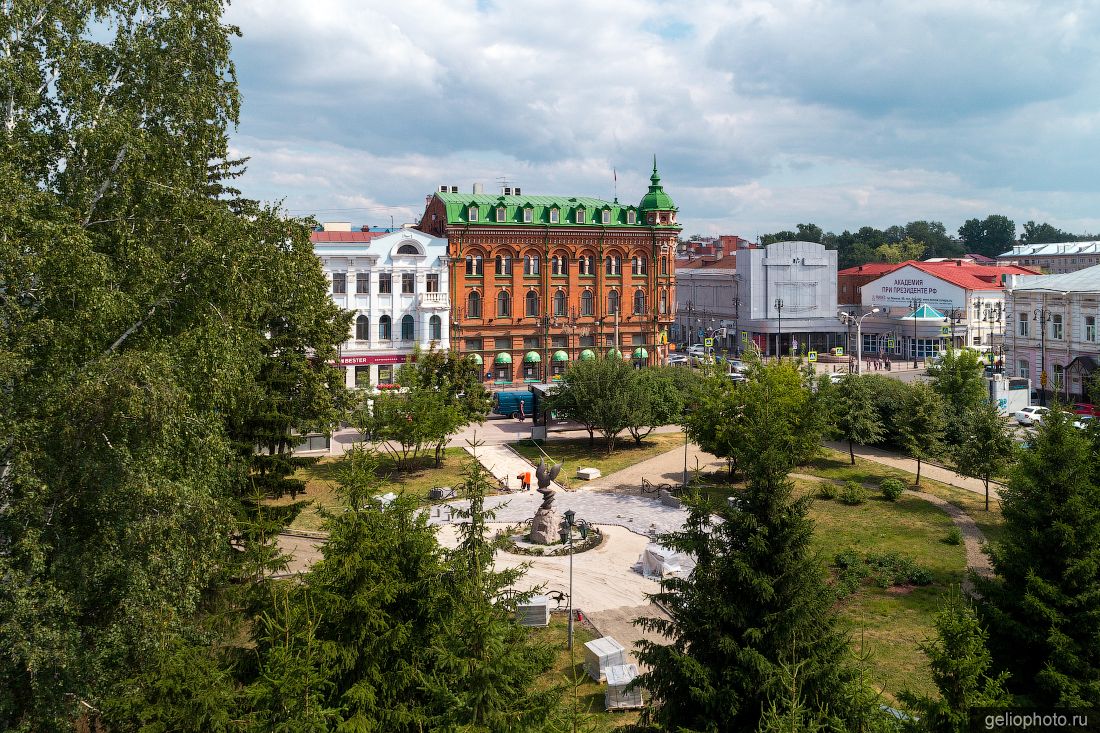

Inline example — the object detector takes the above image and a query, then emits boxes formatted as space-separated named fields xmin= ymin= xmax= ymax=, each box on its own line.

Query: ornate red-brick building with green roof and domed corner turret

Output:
xmin=419 ymin=161 xmax=680 ymax=385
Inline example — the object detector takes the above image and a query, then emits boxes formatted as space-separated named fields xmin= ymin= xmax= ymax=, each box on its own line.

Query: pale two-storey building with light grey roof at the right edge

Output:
xmin=1004 ymin=265 xmax=1100 ymax=402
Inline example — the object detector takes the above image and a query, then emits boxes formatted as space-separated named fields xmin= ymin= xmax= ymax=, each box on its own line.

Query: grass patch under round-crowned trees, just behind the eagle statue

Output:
xmin=509 ymin=433 xmax=684 ymax=483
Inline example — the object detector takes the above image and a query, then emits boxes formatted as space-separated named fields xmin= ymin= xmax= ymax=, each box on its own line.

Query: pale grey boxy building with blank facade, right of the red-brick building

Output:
xmin=730 ymin=242 xmax=846 ymax=355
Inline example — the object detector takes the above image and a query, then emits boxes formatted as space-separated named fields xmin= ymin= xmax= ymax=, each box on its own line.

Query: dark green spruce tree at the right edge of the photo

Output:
xmin=978 ymin=411 xmax=1100 ymax=707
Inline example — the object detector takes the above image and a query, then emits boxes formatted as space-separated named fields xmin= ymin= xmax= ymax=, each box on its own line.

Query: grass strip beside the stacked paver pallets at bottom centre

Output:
xmin=531 ymin=613 xmax=639 ymax=733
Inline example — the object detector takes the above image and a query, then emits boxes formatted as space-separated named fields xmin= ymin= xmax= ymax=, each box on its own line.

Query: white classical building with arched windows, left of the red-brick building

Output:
xmin=311 ymin=223 xmax=450 ymax=387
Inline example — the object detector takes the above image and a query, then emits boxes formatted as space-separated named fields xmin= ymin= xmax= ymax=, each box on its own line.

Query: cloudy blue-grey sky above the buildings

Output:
xmin=227 ymin=0 xmax=1100 ymax=238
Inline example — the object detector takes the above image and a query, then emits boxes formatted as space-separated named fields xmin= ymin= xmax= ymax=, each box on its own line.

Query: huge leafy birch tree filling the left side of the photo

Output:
xmin=0 ymin=0 xmax=348 ymax=730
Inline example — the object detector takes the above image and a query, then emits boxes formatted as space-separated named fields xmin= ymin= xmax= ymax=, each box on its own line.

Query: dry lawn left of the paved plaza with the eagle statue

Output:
xmin=265 ymin=448 xmax=481 ymax=532
